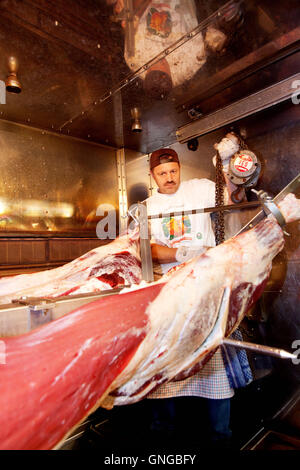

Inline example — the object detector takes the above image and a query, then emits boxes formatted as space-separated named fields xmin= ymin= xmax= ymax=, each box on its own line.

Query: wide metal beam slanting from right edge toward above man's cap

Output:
xmin=176 ymin=73 xmax=300 ymax=143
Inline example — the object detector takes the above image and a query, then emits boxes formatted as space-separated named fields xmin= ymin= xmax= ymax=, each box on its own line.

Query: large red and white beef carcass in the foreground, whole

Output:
xmin=0 ymin=195 xmax=300 ymax=449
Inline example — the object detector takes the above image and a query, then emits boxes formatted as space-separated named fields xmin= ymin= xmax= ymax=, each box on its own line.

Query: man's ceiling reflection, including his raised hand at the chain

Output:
xmin=107 ymin=0 xmax=244 ymax=98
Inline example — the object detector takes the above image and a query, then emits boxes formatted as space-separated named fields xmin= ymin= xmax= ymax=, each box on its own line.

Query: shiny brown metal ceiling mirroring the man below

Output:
xmin=0 ymin=0 xmax=300 ymax=153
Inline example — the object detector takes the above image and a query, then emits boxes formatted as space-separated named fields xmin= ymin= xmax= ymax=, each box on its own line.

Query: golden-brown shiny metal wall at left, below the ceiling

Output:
xmin=0 ymin=122 xmax=118 ymax=237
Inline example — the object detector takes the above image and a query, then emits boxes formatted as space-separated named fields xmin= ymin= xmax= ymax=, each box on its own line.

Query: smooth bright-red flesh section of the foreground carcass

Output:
xmin=0 ymin=286 xmax=160 ymax=449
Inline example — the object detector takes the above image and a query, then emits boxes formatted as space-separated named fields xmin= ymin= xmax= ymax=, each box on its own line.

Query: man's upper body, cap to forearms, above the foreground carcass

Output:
xmin=147 ymin=149 xmax=215 ymax=274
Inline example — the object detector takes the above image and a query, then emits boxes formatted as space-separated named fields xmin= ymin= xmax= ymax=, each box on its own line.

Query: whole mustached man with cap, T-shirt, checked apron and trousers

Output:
xmin=146 ymin=145 xmax=251 ymax=443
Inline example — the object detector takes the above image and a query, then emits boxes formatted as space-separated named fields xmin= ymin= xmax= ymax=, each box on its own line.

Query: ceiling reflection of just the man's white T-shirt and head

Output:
xmin=108 ymin=0 xmax=205 ymax=95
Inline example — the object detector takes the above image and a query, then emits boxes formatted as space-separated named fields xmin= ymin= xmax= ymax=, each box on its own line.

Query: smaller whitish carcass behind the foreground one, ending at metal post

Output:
xmin=0 ymin=230 xmax=142 ymax=304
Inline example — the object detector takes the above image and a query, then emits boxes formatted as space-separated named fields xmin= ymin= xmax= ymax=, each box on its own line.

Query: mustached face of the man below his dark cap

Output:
xmin=152 ymin=162 xmax=180 ymax=194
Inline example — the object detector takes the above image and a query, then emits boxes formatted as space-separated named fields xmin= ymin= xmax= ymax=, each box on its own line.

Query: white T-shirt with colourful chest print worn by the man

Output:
xmin=146 ymin=178 xmax=215 ymax=273
